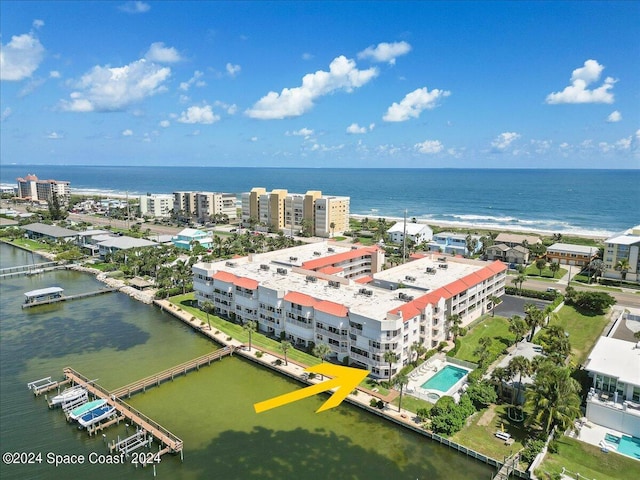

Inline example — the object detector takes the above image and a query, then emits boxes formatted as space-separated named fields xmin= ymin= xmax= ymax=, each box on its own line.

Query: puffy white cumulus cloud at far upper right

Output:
xmin=545 ymin=60 xmax=616 ymax=104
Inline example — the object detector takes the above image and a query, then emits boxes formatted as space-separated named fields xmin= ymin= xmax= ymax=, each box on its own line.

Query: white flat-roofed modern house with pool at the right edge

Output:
xmin=584 ymin=337 xmax=640 ymax=437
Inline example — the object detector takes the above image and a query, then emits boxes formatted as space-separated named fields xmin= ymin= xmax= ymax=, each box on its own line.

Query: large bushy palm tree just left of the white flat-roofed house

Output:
xmin=527 ymin=364 xmax=581 ymax=434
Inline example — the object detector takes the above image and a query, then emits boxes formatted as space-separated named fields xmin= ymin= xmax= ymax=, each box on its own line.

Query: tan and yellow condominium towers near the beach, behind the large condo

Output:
xmin=242 ymin=187 xmax=350 ymax=237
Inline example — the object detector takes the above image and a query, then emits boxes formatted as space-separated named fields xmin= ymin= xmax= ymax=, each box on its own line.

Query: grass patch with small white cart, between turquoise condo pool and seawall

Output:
xmin=451 ymin=405 xmax=530 ymax=460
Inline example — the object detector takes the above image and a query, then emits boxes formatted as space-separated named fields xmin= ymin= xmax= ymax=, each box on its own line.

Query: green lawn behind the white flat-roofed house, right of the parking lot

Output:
xmin=534 ymin=305 xmax=609 ymax=365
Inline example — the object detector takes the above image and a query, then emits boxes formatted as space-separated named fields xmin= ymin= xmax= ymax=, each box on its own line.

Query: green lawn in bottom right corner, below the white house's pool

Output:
xmin=535 ymin=437 xmax=640 ymax=480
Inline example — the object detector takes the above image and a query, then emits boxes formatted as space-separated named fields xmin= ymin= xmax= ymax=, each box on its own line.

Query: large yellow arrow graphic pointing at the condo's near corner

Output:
xmin=253 ymin=363 xmax=369 ymax=413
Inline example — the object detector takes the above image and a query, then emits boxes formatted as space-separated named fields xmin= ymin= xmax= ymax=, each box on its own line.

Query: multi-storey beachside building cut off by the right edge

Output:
xmin=603 ymin=225 xmax=640 ymax=282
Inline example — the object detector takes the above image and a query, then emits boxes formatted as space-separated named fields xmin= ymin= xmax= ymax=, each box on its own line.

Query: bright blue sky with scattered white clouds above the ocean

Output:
xmin=0 ymin=0 xmax=640 ymax=168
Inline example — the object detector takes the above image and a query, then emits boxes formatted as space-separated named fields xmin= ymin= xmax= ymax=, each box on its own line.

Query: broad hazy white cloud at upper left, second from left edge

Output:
xmin=60 ymin=59 xmax=171 ymax=112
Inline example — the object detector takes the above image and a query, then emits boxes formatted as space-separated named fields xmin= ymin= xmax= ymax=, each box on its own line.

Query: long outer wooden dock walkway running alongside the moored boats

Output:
xmin=64 ymin=367 xmax=183 ymax=455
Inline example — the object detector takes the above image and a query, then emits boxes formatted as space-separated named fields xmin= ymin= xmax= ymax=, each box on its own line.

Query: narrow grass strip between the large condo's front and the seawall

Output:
xmin=168 ymin=293 xmax=321 ymax=366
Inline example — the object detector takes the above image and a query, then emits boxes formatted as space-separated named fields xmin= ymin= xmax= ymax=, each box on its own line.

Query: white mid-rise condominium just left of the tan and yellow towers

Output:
xmin=173 ymin=192 xmax=238 ymax=223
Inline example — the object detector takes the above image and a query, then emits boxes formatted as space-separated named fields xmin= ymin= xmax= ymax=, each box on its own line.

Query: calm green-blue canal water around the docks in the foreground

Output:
xmin=0 ymin=244 xmax=492 ymax=480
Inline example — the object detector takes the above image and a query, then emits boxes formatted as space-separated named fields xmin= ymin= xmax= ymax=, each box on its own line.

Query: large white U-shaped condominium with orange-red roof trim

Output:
xmin=192 ymin=243 xmax=506 ymax=378
